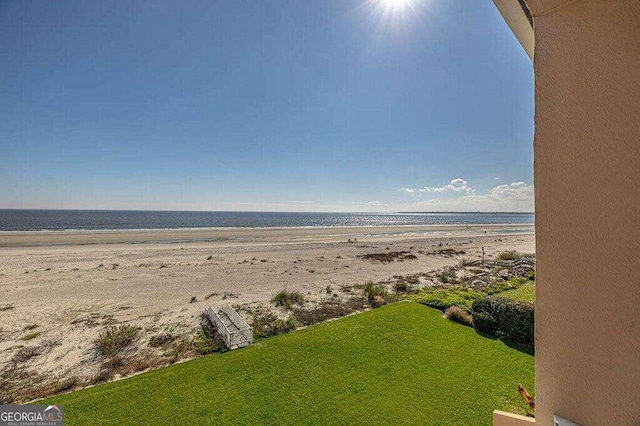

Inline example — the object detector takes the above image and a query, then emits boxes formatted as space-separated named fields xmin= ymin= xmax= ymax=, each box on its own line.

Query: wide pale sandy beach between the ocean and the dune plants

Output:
xmin=0 ymin=225 xmax=535 ymax=400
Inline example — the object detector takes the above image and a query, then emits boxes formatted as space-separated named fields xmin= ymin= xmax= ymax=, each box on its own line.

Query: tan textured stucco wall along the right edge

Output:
xmin=528 ymin=0 xmax=640 ymax=425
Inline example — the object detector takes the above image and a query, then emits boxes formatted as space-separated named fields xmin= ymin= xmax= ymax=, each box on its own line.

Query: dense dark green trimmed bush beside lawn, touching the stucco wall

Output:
xmin=471 ymin=297 xmax=534 ymax=346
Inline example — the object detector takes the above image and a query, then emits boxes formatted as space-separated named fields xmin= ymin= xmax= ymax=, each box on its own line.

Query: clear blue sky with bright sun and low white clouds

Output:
xmin=0 ymin=0 xmax=533 ymax=212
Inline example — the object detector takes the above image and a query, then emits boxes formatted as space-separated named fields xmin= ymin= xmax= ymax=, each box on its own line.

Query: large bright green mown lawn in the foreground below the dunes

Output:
xmin=39 ymin=302 xmax=534 ymax=425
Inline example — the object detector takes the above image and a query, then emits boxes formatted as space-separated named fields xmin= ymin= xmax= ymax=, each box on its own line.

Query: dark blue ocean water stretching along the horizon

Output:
xmin=0 ymin=210 xmax=534 ymax=231
